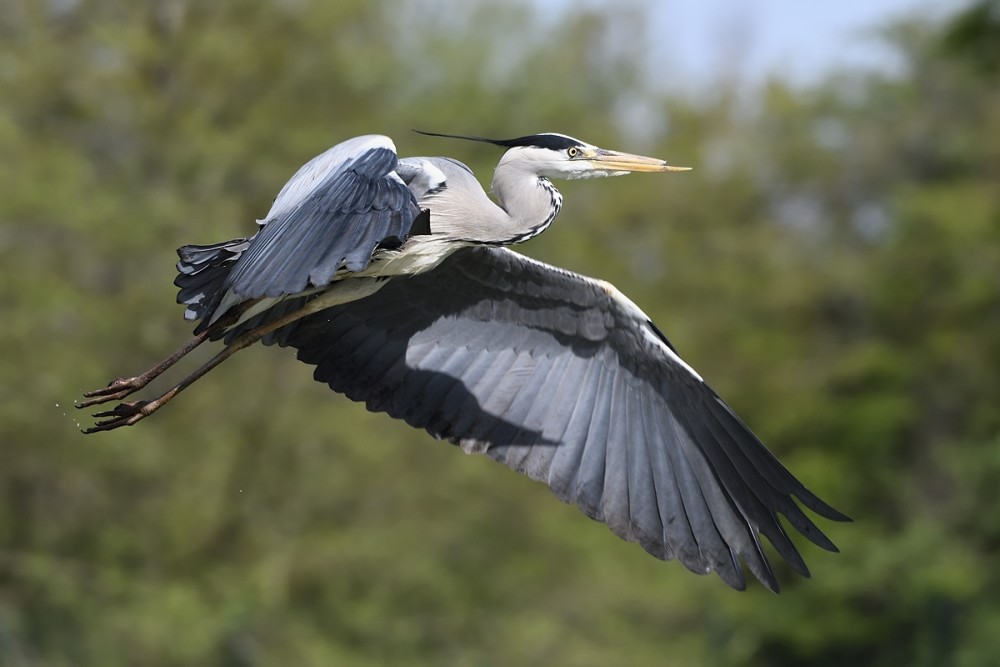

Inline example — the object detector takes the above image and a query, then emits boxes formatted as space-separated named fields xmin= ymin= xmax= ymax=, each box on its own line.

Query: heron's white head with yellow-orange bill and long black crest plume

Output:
xmin=418 ymin=130 xmax=690 ymax=179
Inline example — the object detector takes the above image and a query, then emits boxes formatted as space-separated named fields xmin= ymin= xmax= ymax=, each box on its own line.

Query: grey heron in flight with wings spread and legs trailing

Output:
xmin=77 ymin=132 xmax=850 ymax=593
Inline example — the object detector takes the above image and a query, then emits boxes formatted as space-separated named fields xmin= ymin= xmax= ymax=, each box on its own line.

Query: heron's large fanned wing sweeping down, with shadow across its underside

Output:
xmin=281 ymin=248 xmax=846 ymax=591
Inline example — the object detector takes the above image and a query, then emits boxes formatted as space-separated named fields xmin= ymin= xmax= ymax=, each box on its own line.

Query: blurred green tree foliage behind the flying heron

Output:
xmin=0 ymin=0 xmax=1000 ymax=667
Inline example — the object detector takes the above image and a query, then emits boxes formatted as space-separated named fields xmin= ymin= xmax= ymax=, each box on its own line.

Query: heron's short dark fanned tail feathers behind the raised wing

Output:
xmin=174 ymin=239 xmax=252 ymax=324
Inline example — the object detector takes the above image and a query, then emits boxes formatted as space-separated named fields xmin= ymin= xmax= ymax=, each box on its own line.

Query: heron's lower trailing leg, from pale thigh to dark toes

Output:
xmin=83 ymin=278 xmax=384 ymax=433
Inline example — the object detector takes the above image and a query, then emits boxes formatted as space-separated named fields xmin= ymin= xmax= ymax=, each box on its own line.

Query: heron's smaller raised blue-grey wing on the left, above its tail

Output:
xmin=224 ymin=135 xmax=420 ymax=299
